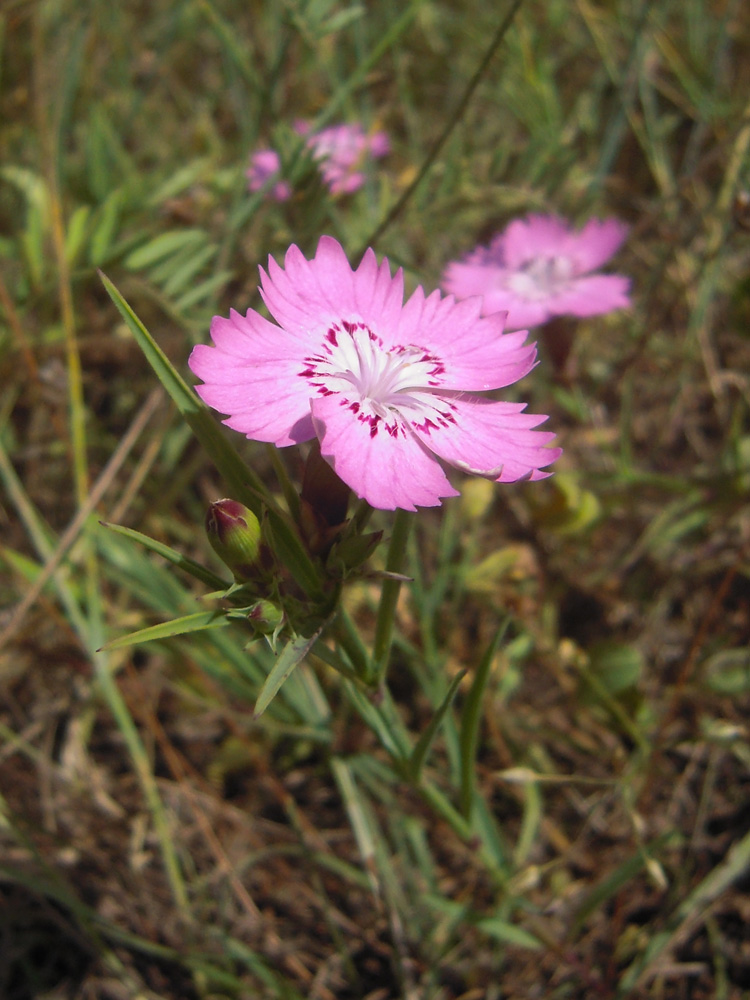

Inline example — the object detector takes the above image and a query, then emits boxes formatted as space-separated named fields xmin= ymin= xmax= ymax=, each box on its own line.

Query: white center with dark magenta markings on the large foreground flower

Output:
xmin=300 ymin=320 xmax=454 ymax=437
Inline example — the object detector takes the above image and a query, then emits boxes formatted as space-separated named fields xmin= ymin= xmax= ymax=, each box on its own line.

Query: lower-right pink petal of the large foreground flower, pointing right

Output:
xmin=414 ymin=397 xmax=561 ymax=483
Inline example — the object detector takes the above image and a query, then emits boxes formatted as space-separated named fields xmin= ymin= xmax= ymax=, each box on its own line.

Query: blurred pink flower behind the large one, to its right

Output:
xmin=443 ymin=215 xmax=630 ymax=330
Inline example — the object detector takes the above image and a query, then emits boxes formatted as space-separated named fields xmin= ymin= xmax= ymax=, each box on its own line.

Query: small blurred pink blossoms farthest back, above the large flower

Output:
xmin=246 ymin=121 xmax=390 ymax=201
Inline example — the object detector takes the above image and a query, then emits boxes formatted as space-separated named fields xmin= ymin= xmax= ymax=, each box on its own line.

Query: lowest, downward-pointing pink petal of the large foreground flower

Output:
xmin=312 ymin=396 xmax=458 ymax=510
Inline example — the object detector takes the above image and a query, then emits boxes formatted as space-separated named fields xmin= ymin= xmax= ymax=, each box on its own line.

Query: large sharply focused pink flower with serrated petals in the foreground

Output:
xmin=189 ymin=236 xmax=560 ymax=510
